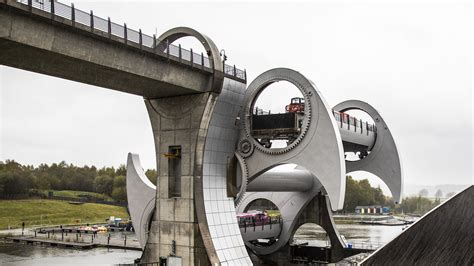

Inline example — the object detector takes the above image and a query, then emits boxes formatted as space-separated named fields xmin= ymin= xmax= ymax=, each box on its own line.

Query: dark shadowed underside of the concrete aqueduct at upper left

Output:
xmin=0 ymin=39 xmax=199 ymax=98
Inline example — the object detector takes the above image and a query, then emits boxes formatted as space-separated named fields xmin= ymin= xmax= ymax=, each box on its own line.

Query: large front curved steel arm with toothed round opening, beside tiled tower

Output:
xmin=240 ymin=68 xmax=346 ymax=210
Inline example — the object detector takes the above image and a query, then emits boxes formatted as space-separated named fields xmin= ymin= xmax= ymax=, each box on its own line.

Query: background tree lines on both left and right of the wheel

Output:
xmin=0 ymin=160 xmax=440 ymax=214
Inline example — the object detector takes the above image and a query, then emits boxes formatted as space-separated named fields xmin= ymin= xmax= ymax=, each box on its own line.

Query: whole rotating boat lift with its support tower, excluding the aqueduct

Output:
xmin=127 ymin=28 xmax=403 ymax=265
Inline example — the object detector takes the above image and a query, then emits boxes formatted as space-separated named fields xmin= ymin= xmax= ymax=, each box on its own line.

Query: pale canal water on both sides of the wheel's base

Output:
xmin=0 ymin=224 xmax=403 ymax=266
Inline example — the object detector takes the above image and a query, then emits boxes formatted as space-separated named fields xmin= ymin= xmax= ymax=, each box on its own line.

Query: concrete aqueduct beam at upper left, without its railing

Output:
xmin=0 ymin=0 xmax=212 ymax=98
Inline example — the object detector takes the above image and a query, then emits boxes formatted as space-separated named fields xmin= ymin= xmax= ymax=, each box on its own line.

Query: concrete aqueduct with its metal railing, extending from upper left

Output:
xmin=0 ymin=0 xmax=246 ymax=98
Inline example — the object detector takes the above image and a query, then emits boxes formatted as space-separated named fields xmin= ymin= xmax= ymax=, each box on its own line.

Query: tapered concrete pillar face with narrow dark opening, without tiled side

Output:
xmin=141 ymin=93 xmax=215 ymax=265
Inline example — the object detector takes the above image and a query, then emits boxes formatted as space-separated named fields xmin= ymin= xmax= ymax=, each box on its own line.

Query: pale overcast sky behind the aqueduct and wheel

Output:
xmin=0 ymin=1 xmax=474 ymax=195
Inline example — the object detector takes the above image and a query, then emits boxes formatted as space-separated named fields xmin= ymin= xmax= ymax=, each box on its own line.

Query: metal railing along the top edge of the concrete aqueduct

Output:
xmin=13 ymin=0 xmax=247 ymax=81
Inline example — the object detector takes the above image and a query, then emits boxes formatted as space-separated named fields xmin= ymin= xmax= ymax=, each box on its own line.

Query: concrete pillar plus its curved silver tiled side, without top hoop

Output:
xmin=142 ymin=79 xmax=251 ymax=265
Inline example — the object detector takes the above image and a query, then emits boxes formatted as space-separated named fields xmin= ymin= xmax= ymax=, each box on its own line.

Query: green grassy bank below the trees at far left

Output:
xmin=0 ymin=199 xmax=128 ymax=229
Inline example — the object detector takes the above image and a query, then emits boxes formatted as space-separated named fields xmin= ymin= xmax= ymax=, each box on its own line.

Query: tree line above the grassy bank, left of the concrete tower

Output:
xmin=0 ymin=160 xmax=156 ymax=201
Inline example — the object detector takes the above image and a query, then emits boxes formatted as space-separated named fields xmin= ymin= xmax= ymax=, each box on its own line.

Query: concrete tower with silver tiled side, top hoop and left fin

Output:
xmin=131 ymin=27 xmax=251 ymax=265
